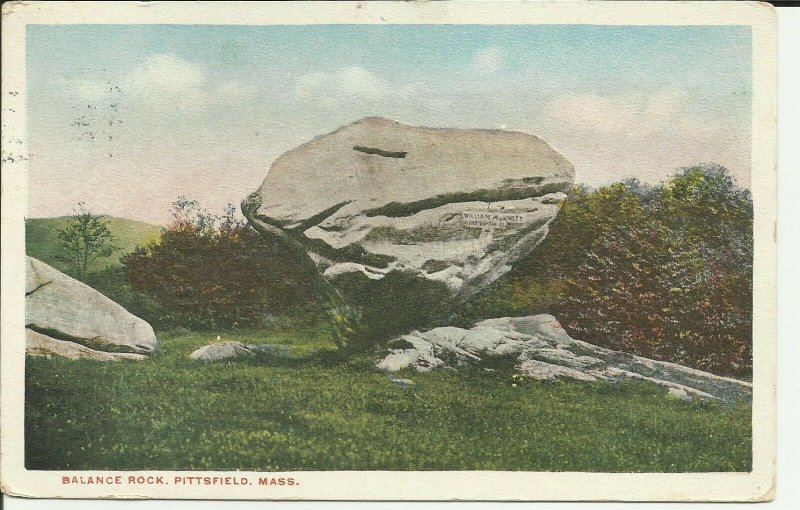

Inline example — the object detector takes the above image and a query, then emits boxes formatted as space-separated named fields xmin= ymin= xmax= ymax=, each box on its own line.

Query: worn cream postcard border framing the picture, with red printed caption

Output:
xmin=0 ymin=2 xmax=776 ymax=501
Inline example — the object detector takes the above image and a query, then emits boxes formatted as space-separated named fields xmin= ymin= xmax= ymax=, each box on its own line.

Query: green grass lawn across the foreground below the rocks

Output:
xmin=25 ymin=326 xmax=752 ymax=472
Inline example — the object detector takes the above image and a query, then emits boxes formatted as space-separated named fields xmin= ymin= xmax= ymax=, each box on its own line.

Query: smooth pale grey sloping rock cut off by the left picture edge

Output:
xmin=25 ymin=257 xmax=158 ymax=361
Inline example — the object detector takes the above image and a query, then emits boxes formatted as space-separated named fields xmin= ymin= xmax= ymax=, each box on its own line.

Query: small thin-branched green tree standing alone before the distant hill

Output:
xmin=57 ymin=202 xmax=116 ymax=280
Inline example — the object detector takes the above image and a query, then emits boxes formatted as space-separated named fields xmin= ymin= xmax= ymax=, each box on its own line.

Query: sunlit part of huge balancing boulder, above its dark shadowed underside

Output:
xmin=242 ymin=118 xmax=575 ymax=304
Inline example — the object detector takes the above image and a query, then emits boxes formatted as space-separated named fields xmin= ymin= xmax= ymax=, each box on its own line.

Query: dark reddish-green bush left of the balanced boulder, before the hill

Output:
xmin=122 ymin=197 xmax=314 ymax=327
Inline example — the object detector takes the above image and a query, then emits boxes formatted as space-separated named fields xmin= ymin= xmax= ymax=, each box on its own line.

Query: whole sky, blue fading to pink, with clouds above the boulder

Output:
xmin=27 ymin=25 xmax=752 ymax=223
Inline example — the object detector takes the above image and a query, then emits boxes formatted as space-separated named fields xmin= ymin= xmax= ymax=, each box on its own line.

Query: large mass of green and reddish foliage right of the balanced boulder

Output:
xmin=484 ymin=165 xmax=753 ymax=376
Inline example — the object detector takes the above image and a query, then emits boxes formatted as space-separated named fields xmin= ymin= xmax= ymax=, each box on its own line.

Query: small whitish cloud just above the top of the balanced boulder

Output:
xmin=295 ymin=66 xmax=392 ymax=100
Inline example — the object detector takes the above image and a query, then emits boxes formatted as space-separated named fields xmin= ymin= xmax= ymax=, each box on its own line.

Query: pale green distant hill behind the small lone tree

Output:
xmin=25 ymin=216 xmax=161 ymax=271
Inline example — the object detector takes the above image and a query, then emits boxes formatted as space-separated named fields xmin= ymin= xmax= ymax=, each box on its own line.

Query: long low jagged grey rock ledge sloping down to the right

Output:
xmin=378 ymin=314 xmax=752 ymax=401
